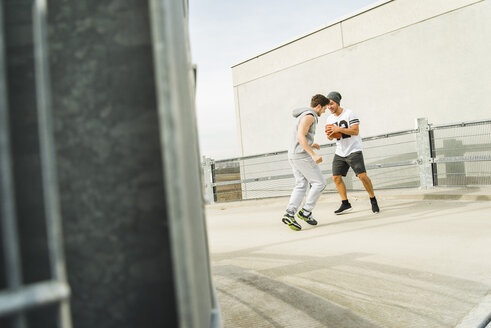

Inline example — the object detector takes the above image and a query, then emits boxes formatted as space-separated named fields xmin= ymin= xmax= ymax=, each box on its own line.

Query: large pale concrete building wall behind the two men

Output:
xmin=232 ymin=0 xmax=491 ymax=156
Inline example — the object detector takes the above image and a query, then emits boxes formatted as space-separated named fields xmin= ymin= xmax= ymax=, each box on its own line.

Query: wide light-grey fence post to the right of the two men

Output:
xmin=416 ymin=118 xmax=433 ymax=189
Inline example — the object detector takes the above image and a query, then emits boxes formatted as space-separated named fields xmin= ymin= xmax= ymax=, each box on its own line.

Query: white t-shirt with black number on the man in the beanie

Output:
xmin=326 ymin=108 xmax=362 ymax=157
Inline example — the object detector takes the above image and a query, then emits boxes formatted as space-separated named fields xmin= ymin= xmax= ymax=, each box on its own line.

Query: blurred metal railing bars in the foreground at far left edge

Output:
xmin=0 ymin=0 xmax=72 ymax=328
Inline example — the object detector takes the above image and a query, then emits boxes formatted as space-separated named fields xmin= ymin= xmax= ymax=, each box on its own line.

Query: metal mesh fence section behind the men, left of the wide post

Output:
xmin=209 ymin=130 xmax=419 ymax=202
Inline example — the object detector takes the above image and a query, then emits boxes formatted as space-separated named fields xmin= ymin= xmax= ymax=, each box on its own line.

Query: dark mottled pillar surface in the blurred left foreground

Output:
xmin=48 ymin=0 xmax=177 ymax=328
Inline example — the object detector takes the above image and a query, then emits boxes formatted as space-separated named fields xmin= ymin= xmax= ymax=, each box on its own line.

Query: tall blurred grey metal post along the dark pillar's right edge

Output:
xmin=149 ymin=0 xmax=219 ymax=328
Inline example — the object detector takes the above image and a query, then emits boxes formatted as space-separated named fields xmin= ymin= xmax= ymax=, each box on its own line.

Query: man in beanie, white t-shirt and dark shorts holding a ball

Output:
xmin=326 ymin=91 xmax=380 ymax=214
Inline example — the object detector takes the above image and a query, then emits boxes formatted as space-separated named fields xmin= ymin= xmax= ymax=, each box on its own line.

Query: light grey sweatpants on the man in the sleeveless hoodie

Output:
xmin=287 ymin=156 xmax=326 ymax=214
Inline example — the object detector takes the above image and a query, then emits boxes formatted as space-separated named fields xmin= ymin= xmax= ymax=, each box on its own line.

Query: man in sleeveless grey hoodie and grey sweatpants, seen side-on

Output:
xmin=282 ymin=94 xmax=329 ymax=231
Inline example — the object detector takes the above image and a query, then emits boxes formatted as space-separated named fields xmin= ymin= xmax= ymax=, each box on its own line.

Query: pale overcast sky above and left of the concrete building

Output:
xmin=189 ymin=0 xmax=378 ymax=159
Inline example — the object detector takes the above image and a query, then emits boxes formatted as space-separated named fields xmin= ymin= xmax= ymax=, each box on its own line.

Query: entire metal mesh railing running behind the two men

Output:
xmin=202 ymin=118 xmax=491 ymax=202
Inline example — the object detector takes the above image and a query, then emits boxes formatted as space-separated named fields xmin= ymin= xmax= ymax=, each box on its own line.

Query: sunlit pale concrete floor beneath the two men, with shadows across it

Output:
xmin=206 ymin=189 xmax=491 ymax=328
